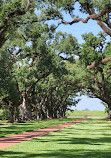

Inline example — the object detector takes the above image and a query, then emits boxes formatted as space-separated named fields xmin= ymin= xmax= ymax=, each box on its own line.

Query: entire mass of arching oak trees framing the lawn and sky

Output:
xmin=0 ymin=0 xmax=111 ymax=122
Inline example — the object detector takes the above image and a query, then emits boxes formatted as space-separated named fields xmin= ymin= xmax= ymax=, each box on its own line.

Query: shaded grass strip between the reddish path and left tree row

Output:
xmin=0 ymin=118 xmax=80 ymax=137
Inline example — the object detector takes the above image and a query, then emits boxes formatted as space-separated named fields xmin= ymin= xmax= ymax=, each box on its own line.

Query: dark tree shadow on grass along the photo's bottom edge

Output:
xmin=0 ymin=149 xmax=111 ymax=158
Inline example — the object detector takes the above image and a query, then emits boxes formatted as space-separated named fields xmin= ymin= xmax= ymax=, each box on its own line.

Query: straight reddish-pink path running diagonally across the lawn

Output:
xmin=0 ymin=118 xmax=86 ymax=149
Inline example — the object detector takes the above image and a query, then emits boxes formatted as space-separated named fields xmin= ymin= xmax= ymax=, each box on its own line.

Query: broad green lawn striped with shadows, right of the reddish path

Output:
xmin=0 ymin=119 xmax=111 ymax=158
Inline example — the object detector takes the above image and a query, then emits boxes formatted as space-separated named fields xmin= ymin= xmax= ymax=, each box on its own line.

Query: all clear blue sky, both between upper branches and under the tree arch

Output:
xmin=49 ymin=4 xmax=111 ymax=111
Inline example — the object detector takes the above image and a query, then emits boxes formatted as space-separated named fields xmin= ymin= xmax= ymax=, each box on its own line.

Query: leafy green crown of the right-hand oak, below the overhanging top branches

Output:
xmin=78 ymin=33 xmax=111 ymax=109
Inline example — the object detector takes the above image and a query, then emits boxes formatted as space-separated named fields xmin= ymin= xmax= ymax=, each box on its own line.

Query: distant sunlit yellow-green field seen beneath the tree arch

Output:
xmin=66 ymin=111 xmax=107 ymax=117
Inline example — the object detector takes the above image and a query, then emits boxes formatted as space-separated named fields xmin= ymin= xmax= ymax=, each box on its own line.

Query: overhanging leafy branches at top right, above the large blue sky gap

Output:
xmin=45 ymin=0 xmax=111 ymax=36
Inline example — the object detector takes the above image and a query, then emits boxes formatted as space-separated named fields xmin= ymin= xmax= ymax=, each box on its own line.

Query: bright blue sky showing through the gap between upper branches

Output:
xmin=56 ymin=2 xmax=111 ymax=43
